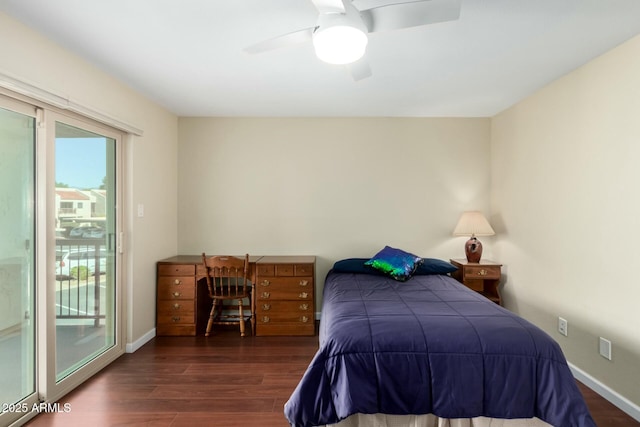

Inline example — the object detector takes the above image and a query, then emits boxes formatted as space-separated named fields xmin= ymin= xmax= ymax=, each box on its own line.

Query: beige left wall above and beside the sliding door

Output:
xmin=0 ymin=13 xmax=178 ymax=343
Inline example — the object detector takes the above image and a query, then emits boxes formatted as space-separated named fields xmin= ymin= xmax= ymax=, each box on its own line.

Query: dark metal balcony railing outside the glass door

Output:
xmin=55 ymin=239 xmax=107 ymax=326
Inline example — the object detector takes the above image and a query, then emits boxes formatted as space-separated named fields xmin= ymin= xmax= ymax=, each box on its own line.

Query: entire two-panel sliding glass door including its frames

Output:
xmin=0 ymin=94 xmax=124 ymax=425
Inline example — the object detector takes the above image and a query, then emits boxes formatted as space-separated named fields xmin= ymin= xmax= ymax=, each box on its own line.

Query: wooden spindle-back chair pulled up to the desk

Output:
xmin=202 ymin=252 xmax=254 ymax=336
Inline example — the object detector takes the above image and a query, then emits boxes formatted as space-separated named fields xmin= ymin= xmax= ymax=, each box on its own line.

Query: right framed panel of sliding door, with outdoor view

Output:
xmin=40 ymin=111 xmax=124 ymax=402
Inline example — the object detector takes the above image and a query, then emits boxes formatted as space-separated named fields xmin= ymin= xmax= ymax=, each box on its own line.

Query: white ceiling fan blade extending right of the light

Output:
xmin=360 ymin=0 xmax=461 ymax=33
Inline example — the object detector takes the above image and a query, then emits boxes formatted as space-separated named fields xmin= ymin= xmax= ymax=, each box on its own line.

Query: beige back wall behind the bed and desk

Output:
xmin=178 ymin=118 xmax=490 ymax=301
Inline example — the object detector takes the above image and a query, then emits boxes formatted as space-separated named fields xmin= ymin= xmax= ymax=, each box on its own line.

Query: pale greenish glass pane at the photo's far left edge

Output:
xmin=0 ymin=103 xmax=36 ymax=424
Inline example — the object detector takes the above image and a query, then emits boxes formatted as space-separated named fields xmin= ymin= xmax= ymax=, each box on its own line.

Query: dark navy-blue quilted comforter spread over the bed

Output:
xmin=285 ymin=271 xmax=595 ymax=427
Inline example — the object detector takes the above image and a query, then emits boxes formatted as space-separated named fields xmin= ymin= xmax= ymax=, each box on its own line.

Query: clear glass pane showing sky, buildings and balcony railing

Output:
xmin=55 ymin=121 xmax=116 ymax=381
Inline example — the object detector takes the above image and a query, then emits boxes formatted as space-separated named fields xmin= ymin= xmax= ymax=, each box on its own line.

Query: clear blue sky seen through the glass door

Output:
xmin=56 ymin=138 xmax=107 ymax=189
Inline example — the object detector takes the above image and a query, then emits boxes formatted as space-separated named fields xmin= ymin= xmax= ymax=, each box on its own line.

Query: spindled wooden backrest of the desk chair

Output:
xmin=202 ymin=252 xmax=250 ymax=298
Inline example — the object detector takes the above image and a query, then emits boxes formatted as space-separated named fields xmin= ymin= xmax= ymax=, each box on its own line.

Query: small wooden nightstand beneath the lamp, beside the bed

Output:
xmin=449 ymin=259 xmax=502 ymax=305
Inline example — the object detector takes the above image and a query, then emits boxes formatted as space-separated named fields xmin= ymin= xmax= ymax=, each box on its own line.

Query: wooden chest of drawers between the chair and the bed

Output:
xmin=255 ymin=256 xmax=316 ymax=336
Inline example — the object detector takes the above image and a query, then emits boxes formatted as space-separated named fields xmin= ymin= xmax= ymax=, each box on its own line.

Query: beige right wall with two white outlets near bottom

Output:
xmin=491 ymin=37 xmax=640 ymax=408
